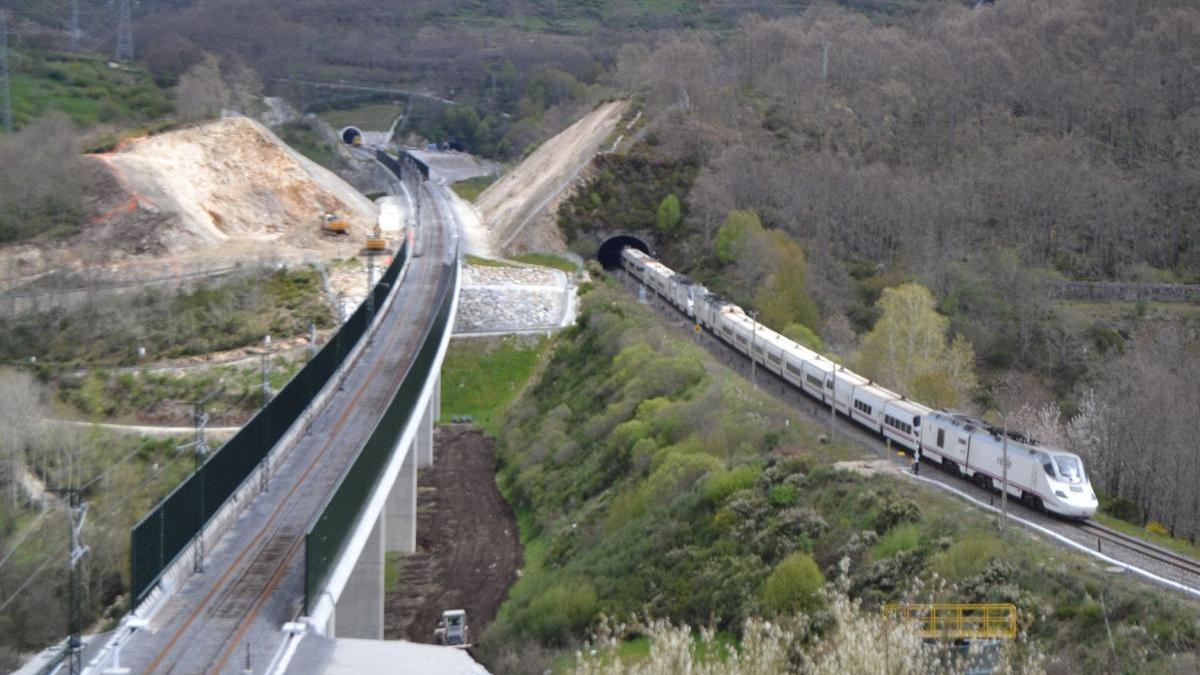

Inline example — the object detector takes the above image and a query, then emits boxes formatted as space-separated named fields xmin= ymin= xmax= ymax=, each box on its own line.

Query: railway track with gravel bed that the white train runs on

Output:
xmin=617 ymin=271 xmax=1200 ymax=589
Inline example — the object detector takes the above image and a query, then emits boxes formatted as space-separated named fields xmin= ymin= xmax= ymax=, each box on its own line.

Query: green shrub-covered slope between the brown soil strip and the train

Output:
xmin=472 ymin=276 xmax=1200 ymax=673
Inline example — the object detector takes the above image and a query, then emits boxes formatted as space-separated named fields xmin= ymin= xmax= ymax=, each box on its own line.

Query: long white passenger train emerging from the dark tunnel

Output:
xmin=620 ymin=247 xmax=1098 ymax=518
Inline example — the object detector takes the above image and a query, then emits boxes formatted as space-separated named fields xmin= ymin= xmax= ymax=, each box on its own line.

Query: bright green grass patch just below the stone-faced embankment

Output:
xmin=442 ymin=338 xmax=548 ymax=429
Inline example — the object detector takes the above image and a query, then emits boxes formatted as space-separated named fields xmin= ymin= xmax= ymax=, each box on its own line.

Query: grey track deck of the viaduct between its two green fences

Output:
xmin=114 ymin=180 xmax=457 ymax=674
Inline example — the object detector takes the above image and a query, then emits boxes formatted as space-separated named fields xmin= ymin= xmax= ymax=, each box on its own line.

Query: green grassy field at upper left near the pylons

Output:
xmin=10 ymin=50 xmax=174 ymax=129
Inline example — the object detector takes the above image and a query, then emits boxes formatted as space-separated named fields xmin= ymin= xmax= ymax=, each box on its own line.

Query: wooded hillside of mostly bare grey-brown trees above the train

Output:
xmin=559 ymin=0 xmax=1200 ymax=540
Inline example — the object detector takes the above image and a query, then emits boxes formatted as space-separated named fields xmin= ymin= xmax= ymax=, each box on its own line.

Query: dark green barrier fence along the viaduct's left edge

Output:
xmin=130 ymin=244 xmax=408 ymax=604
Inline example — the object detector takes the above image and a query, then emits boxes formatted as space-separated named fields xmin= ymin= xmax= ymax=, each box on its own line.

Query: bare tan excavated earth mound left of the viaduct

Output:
xmin=0 ymin=118 xmax=377 ymax=291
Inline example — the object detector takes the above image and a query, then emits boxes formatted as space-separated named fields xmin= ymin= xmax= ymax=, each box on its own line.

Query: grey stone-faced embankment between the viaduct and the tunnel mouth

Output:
xmin=455 ymin=265 xmax=575 ymax=334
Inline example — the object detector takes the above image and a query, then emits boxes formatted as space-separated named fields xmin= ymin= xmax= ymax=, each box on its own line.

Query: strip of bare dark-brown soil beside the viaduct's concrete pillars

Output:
xmin=384 ymin=425 xmax=523 ymax=643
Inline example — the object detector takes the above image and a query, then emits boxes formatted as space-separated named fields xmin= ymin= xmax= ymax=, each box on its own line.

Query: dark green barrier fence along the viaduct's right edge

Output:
xmin=305 ymin=254 xmax=458 ymax=615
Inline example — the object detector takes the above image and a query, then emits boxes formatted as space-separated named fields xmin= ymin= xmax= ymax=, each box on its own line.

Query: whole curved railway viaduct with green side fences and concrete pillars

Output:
xmin=83 ymin=156 xmax=461 ymax=674
